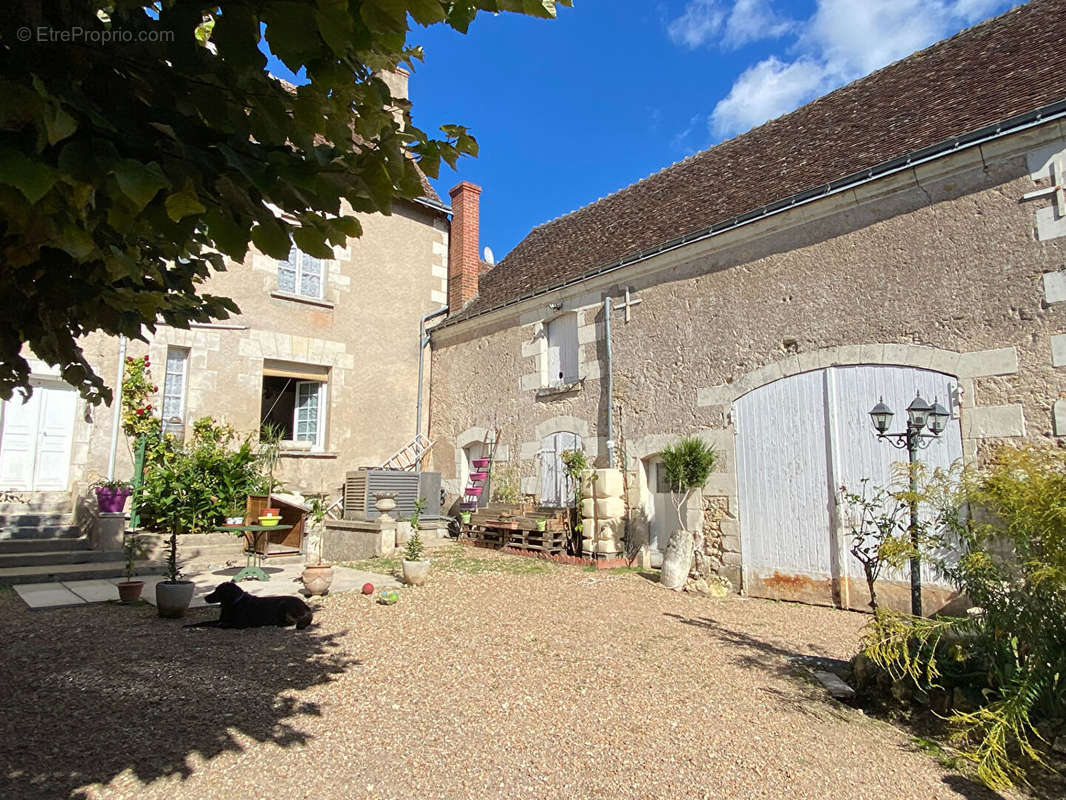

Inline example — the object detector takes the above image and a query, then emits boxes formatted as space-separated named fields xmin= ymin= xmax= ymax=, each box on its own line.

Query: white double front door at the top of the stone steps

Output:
xmin=0 ymin=379 xmax=78 ymax=492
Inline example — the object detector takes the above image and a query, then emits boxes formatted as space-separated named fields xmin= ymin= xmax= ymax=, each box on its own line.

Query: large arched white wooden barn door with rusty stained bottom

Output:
xmin=733 ymin=366 xmax=963 ymax=608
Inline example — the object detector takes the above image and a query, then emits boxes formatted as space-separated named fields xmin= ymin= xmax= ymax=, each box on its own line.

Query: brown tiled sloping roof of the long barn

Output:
xmin=449 ymin=0 xmax=1066 ymax=321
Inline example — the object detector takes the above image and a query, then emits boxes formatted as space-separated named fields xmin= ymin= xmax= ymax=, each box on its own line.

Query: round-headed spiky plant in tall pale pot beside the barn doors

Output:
xmin=659 ymin=436 xmax=718 ymax=591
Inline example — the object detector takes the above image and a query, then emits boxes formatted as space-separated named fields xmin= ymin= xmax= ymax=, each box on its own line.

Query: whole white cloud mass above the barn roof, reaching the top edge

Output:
xmin=699 ymin=0 xmax=1013 ymax=138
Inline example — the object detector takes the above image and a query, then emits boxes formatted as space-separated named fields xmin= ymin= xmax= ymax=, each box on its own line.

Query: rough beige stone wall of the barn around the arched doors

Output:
xmin=432 ymin=123 xmax=1066 ymax=593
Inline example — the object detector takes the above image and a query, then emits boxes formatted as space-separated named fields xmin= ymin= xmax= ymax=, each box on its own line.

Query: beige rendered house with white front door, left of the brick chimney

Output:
xmin=0 ymin=71 xmax=450 ymax=508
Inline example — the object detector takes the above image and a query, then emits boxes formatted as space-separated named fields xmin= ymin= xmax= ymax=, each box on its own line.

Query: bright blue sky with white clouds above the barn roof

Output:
xmin=266 ymin=0 xmax=1017 ymax=259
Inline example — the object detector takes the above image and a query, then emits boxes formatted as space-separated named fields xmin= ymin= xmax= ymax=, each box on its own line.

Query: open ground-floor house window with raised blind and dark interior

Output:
xmin=260 ymin=359 xmax=328 ymax=451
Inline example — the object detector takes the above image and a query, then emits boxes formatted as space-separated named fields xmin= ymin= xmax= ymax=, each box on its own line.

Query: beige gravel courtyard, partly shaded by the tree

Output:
xmin=0 ymin=547 xmax=995 ymax=800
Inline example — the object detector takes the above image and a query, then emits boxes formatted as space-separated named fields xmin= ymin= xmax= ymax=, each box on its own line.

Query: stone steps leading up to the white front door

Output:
xmin=0 ymin=493 xmax=160 ymax=586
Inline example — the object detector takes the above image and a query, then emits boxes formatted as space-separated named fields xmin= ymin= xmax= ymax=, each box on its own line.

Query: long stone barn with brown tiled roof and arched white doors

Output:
xmin=430 ymin=0 xmax=1066 ymax=610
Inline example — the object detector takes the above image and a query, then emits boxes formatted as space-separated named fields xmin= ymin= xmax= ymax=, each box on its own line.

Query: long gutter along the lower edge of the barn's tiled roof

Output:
xmin=430 ymin=99 xmax=1066 ymax=335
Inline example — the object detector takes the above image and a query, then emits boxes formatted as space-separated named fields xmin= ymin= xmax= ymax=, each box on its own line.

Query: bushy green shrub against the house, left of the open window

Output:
xmin=138 ymin=417 xmax=269 ymax=533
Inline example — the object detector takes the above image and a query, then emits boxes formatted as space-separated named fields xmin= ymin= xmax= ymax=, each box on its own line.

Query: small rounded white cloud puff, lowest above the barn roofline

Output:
xmin=710 ymin=55 xmax=825 ymax=138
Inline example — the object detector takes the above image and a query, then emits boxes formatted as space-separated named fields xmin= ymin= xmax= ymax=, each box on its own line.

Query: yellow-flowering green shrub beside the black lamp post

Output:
xmin=863 ymin=446 xmax=1066 ymax=788
